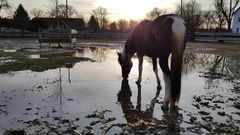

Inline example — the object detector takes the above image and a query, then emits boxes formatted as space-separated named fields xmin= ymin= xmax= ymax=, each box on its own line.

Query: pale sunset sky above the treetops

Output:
xmin=1 ymin=0 xmax=213 ymax=20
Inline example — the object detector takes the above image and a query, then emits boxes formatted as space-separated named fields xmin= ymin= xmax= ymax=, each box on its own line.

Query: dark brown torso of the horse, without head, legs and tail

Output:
xmin=127 ymin=14 xmax=187 ymax=58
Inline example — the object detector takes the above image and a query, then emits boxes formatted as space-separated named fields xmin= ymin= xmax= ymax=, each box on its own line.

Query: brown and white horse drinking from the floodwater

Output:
xmin=118 ymin=14 xmax=187 ymax=108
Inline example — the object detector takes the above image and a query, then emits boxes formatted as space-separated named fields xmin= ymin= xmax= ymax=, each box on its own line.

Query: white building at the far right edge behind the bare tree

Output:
xmin=232 ymin=7 xmax=240 ymax=33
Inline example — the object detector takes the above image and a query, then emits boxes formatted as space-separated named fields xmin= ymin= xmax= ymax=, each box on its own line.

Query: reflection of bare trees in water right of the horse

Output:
xmin=183 ymin=53 xmax=230 ymax=86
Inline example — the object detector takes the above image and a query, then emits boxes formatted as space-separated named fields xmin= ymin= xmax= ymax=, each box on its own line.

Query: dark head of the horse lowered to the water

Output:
xmin=118 ymin=53 xmax=133 ymax=79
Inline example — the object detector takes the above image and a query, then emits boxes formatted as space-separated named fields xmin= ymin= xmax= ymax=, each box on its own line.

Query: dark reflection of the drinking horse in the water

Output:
xmin=117 ymin=79 xmax=180 ymax=134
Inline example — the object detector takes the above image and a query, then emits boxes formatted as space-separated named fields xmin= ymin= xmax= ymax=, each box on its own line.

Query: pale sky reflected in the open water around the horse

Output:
xmin=0 ymin=48 xmax=239 ymax=133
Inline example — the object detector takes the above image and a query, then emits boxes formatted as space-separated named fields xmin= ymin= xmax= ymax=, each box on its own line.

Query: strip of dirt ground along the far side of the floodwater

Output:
xmin=0 ymin=39 xmax=240 ymax=57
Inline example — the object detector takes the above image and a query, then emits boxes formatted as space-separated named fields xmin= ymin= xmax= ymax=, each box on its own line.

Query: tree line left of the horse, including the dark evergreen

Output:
xmin=0 ymin=0 xmax=138 ymax=33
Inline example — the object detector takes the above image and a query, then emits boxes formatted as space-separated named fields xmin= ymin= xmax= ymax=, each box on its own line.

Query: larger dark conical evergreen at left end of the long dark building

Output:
xmin=13 ymin=4 xmax=30 ymax=35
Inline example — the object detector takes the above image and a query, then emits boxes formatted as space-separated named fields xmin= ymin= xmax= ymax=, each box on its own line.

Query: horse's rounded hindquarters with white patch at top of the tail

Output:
xmin=151 ymin=14 xmax=186 ymax=57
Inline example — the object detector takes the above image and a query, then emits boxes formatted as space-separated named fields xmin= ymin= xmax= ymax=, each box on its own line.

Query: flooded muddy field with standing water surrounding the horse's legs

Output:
xmin=0 ymin=42 xmax=240 ymax=135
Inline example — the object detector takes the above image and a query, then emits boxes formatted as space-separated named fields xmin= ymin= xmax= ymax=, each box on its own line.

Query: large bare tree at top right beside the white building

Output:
xmin=214 ymin=0 xmax=240 ymax=30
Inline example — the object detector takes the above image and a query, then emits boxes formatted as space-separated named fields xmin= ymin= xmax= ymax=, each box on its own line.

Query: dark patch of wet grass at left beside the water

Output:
xmin=0 ymin=52 xmax=93 ymax=74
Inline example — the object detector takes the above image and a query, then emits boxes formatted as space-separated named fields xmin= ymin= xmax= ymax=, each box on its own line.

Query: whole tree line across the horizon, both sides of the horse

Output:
xmin=0 ymin=0 xmax=240 ymax=37
